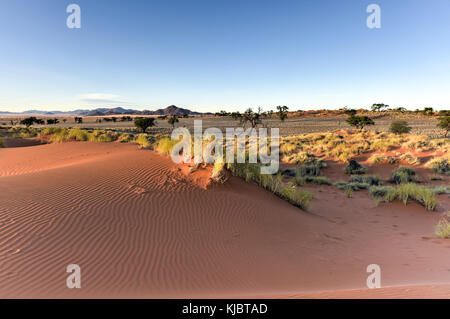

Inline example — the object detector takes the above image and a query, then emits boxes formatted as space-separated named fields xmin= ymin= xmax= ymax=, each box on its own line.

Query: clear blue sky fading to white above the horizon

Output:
xmin=0 ymin=0 xmax=450 ymax=111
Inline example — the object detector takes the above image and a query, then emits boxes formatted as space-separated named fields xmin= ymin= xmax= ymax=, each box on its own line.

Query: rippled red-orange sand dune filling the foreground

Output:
xmin=0 ymin=142 xmax=450 ymax=298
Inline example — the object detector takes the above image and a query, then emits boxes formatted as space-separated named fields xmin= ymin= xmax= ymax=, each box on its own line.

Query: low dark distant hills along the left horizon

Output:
xmin=0 ymin=105 xmax=212 ymax=116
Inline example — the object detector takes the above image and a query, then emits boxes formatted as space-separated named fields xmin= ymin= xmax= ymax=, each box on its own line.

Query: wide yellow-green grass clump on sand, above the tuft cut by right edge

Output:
xmin=369 ymin=183 xmax=436 ymax=211
